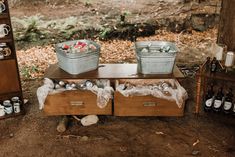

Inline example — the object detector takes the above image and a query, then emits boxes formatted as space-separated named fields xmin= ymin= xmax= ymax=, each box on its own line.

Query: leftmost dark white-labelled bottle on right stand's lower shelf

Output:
xmin=204 ymin=84 xmax=215 ymax=112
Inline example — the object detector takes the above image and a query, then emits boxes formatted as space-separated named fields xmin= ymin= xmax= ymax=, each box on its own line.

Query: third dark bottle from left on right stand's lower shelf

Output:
xmin=223 ymin=88 xmax=233 ymax=114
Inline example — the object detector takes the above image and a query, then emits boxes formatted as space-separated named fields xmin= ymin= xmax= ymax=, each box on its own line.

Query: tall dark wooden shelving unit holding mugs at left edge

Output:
xmin=0 ymin=0 xmax=24 ymax=119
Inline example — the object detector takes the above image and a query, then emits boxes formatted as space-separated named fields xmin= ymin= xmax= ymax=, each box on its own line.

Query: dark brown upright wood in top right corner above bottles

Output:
xmin=217 ymin=0 xmax=235 ymax=51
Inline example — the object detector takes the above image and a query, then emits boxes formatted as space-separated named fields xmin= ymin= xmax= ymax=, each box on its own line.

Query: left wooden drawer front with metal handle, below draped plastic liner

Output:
xmin=44 ymin=90 xmax=112 ymax=115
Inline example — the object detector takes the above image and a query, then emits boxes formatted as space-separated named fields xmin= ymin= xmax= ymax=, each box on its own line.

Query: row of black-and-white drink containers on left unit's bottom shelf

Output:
xmin=0 ymin=96 xmax=22 ymax=118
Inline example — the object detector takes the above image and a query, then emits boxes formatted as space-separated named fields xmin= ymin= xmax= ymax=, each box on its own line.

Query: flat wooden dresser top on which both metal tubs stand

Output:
xmin=44 ymin=64 xmax=184 ymax=79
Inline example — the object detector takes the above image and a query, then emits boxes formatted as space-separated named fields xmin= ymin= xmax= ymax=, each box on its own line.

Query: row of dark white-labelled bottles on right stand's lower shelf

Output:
xmin=204 ymin=84 xmax=235 ymax=115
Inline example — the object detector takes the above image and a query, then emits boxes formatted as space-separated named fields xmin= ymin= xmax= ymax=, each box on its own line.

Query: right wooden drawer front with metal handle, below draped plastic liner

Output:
xmin=114 ymin=91 xmax=184 ymax=116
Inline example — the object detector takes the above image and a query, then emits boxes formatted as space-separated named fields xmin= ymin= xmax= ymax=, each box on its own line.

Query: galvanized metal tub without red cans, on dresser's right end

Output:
xmin=135 ymin=41 xmax=179 ymax=74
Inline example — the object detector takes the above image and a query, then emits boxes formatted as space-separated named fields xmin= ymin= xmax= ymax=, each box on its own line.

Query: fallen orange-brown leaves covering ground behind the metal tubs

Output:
xmin=17 ymin=28 xmax=217 ymax=79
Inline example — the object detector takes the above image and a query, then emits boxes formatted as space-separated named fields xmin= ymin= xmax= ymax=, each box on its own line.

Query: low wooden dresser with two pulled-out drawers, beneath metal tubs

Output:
xmin=44 ymin=64 xmax=184 ymax=116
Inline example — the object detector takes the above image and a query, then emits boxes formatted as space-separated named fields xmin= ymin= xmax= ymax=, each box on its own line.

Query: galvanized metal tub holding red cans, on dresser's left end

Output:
xmin=55 ymin=40 xmax=100 ymax=75
